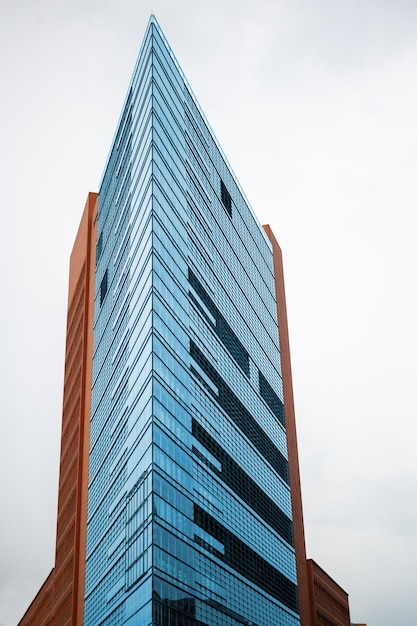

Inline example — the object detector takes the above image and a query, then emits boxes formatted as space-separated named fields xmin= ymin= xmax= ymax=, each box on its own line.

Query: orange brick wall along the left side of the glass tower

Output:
xmin=19 ymin=193 xmax=97 ymax=626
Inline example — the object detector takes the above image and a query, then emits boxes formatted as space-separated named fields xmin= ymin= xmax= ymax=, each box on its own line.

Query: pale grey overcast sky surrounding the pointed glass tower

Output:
xmin=0 ymin=0 xmax=417 ymax=626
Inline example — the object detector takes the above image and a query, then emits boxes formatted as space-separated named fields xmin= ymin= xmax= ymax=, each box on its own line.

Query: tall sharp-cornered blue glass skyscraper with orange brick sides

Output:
xmin=21 ymin=18 xmax=311 ymax=626
